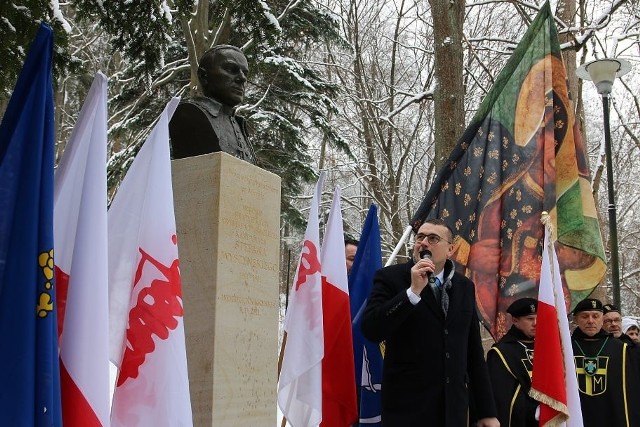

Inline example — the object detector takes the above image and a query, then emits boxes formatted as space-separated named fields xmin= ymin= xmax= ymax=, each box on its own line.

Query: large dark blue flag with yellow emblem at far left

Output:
xmin=0 ymin=24 xmax=62 ymax=427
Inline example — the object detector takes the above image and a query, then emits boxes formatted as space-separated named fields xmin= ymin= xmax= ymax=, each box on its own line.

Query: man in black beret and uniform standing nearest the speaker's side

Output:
xmin=487 ymin=298 xmax=538 ymax=427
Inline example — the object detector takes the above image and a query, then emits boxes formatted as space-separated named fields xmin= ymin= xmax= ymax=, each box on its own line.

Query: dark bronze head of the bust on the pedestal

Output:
xmin=198 ymin=45 xmax=249 ymax=107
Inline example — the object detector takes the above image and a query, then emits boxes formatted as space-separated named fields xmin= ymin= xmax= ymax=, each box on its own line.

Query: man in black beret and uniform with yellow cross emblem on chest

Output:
xmin=572 ymin=298 xmax=640 ymax=427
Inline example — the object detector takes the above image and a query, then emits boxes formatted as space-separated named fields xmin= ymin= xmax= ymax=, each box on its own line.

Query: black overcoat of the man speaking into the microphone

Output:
xmin=361 ymin=261 xmax=496 ymax=427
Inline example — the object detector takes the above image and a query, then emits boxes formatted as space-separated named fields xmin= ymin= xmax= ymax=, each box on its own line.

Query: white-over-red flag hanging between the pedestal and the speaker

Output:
xmin=320 ymin=187 xmax=358 ymax=427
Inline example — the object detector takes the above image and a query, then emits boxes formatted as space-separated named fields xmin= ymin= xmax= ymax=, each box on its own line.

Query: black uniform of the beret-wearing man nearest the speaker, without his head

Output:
xmin=487 ymin=326 xmax=538 ymax=427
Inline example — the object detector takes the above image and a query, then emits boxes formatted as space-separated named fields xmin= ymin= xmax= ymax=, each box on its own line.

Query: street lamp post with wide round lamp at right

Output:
xmin=576 ymin=58 xmax=631 ymax=309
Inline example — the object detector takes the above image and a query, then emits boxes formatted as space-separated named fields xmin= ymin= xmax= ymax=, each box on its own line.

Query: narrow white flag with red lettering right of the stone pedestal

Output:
xmin=278 ymin=172 xmax=324 ymax=427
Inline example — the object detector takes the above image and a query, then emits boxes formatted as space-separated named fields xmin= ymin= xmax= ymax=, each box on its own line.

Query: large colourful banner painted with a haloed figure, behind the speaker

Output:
xmin=411 ymin=5 xmax=606 ymax=339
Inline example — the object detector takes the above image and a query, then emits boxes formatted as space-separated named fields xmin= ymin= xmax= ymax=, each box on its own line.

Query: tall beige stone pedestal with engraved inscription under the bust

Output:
xmin=172 ymin=152 xmax=280 ymax=427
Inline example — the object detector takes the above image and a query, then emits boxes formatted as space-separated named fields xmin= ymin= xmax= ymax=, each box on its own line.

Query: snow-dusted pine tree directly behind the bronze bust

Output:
xmin=70 ymin=0 xmax=348 ymax=225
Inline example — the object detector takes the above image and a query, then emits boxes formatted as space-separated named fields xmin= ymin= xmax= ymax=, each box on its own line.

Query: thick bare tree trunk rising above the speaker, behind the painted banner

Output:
xmin=429 ymin=0 xmax=465 ymax=169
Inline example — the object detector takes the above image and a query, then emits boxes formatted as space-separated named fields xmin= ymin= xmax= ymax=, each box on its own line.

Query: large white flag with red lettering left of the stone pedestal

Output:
xmin=108 ymin=98 xmax=192 ymax=427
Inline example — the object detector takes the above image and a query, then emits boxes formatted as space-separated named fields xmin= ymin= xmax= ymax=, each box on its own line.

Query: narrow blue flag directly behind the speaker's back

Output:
xmin=349 ymin=204 xmax=382 ymax=427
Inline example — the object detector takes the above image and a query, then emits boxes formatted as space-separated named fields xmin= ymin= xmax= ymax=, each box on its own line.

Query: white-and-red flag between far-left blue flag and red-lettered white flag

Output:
xmin=53 ymin=72 xmax=110 ymax=427
